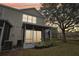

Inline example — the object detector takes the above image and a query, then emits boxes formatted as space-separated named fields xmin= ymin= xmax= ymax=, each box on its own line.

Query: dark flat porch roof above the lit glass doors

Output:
xmin=23 ymin=23 xmax=51 ymax=30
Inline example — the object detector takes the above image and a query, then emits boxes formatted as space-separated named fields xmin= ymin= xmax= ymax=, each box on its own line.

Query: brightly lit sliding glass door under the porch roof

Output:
xmin=24 ymin=30 xmax=41 ymax=43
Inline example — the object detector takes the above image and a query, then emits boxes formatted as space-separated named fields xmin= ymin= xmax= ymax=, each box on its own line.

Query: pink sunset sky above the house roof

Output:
xmin=2 ymin=3 xmax=41 ymax=9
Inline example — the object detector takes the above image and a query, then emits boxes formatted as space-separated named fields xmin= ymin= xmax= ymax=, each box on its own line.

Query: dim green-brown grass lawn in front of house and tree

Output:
xmin=0 ymin=41 xmax=79 ymax=56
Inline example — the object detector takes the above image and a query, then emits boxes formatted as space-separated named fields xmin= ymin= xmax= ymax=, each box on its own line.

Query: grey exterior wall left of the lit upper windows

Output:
xmin=1 ymin=7 xmax=22 ymax=45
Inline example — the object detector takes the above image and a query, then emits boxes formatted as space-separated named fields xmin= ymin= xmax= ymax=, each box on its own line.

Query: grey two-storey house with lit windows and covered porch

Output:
xmin=0 ymin=5 xmax=52 ymax=50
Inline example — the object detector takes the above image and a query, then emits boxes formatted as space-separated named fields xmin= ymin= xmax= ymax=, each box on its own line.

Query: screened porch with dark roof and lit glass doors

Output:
xmin=23 ymin=23 xmax=51 ymax=46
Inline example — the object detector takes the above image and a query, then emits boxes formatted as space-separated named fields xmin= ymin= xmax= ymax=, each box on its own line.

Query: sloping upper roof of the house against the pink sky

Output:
xmin=0 ymin=4 xmax=45 ymax=18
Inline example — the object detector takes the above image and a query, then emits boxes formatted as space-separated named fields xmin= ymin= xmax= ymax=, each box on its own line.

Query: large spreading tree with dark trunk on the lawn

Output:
xmin=41 ymin=3 xmax=79 ymax=42
